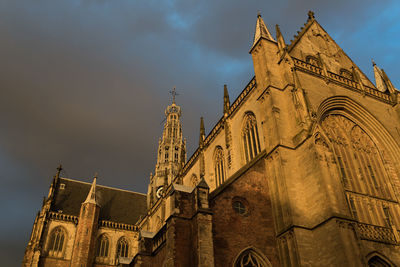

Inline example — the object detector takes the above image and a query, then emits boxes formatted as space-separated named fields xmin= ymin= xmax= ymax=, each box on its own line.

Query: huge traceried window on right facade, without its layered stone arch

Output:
xmin=321 ymin=114 xmax=400 ymax=228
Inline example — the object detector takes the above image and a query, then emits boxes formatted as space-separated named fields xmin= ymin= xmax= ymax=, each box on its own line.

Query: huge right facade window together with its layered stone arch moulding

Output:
xmin=314 ymin=96 xmax=400 ymax=228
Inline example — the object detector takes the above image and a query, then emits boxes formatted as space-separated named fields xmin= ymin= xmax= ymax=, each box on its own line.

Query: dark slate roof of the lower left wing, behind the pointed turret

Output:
xmin=51 ymin=178 xmax=147 ymax=224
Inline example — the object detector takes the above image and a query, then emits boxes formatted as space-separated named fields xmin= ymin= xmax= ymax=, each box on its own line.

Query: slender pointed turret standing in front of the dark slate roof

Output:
xmin=71 ymin=176 xmax=100 ymax=266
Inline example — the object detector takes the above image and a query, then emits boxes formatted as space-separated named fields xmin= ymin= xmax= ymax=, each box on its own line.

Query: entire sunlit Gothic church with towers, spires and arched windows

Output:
xmin=23 ymin=11 xmax=400 ymax=267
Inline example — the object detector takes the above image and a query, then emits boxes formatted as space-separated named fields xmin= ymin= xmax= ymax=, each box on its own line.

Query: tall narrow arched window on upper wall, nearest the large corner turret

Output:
xmin=242 ymin=112 xmax=261 ymax=163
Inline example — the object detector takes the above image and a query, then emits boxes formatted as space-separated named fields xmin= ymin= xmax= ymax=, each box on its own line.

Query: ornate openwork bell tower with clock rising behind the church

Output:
xmin=147 ymin=88 xmax=186 ymax=208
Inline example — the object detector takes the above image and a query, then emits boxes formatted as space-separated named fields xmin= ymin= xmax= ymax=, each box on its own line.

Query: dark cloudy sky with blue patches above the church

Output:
xmin=0 ymin=0 xmax=400 ymax=266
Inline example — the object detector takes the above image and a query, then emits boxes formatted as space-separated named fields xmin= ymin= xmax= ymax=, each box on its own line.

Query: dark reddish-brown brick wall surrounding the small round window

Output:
xmin=210 ymin=158 xmax=279 ymax=267
